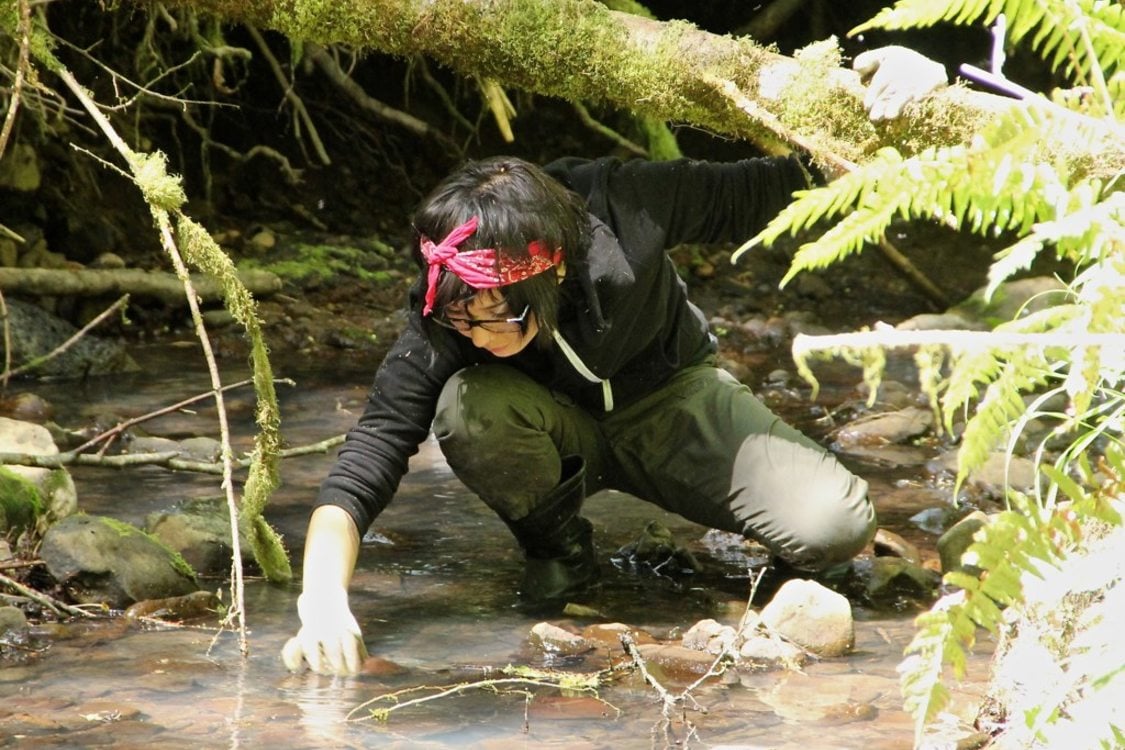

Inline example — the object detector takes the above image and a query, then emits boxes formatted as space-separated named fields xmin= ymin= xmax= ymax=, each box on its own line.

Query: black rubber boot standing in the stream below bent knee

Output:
xmin=507 ymin=455 xmax=601 ymax=607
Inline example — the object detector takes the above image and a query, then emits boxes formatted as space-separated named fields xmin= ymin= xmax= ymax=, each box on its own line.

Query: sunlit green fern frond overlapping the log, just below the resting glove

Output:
xmin=751 ymin=101 xmax=1093 ymax=286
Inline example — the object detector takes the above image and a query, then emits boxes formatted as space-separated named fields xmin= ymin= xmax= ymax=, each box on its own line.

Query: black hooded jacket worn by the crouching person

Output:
xmin=317 ymin=159 xmax=808 ymax=534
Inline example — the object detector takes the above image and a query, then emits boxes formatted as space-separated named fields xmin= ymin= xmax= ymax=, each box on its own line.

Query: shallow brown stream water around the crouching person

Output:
xmin=0 ymin=347 xmax=987 ymax=750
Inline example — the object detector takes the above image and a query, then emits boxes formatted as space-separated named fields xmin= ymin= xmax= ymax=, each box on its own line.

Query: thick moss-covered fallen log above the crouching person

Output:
xmin=134 ymin=0 xmax=1013 ymax=162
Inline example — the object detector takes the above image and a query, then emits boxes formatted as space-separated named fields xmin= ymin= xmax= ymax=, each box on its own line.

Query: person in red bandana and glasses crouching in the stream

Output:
xmin=282 ymin=51 xmax=949 ymax=674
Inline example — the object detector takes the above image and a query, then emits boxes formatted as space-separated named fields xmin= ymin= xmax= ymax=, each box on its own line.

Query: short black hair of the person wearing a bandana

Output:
xmin=414 ymin=156 xmax=590 ymax=345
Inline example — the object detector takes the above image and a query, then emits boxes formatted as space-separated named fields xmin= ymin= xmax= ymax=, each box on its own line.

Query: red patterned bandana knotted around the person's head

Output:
xmin=420 ymin=216 xmax=563 ymax=315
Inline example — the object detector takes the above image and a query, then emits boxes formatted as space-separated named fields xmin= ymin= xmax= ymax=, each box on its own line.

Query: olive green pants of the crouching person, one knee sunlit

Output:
xmin=433 ymin=364 xmax=875 ymax=570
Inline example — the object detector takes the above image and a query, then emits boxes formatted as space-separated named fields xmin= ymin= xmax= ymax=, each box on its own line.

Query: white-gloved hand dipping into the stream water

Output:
xmin=281 ymin=588 xmax=367 ymax=675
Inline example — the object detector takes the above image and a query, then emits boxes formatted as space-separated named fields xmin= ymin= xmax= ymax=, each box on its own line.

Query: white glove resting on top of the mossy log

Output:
xmin=852 ymin=46 xmax=948 ymax=120
